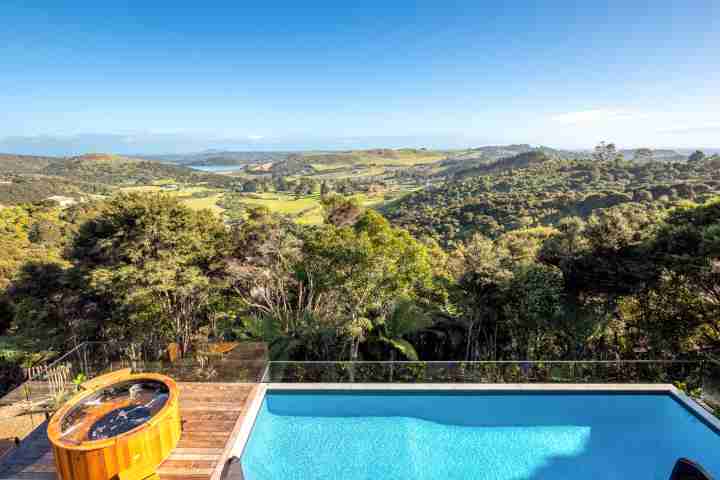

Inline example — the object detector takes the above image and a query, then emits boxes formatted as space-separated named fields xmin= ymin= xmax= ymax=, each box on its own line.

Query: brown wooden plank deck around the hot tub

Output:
xmin=0 ymin=383 xmax=257 ymax=480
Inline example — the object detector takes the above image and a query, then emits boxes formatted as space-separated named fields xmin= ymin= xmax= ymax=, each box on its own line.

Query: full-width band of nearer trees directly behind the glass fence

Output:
xmin=0 ymin=180 xmax=720 ymax=390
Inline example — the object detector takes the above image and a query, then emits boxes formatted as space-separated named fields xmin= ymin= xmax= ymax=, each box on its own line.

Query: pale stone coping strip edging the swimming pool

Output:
xmin=231 ymin=383 xmax=720 ymax=458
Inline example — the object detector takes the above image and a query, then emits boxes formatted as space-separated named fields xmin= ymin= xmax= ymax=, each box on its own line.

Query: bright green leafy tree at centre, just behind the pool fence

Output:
xmin=301 ymin=211 xmax=434 ymax=360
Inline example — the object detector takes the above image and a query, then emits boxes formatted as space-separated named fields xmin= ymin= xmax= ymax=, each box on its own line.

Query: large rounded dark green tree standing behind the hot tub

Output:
xmin=73 ymin=194 xmax=227 ymax=352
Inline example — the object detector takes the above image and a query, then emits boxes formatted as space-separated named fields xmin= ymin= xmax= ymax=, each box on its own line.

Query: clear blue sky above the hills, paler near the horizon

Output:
xmin=0 ymin=0 xmax=720 ymax=152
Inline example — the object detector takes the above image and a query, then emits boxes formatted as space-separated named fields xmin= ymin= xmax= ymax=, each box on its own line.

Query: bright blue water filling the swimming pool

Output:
xmin=242 ymin=391 xmax=720 ymax=480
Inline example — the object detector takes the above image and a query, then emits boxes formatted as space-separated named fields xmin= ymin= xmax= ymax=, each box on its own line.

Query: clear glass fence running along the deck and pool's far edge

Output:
xmin=0 ymin=342 xmax=720 ymax=448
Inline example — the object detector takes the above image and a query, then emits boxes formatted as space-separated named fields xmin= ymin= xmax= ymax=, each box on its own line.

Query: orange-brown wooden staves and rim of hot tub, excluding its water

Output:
xmin=48 ymin=373 xmax=181 ymax=480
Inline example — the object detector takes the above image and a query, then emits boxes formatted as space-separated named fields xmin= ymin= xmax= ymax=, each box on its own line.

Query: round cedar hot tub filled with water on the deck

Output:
xmin=48 ymin=369 xmax=181 ymax=480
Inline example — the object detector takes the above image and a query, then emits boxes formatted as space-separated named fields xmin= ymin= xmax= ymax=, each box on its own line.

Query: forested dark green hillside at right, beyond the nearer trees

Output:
xmin=381 ymin=154 xmax=720 ymax=244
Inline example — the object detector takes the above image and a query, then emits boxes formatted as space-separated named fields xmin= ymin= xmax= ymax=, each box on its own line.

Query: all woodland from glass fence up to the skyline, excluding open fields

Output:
xmin=0 ymin=144 xmax=720 ymax=402
